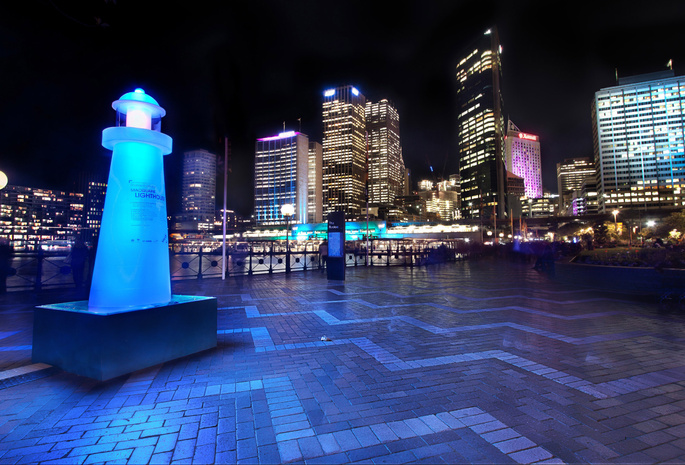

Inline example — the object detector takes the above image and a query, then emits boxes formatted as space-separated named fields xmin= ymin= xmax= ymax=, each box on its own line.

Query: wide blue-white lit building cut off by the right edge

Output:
xmin=592 ymin=70 xmax=685 ymax=213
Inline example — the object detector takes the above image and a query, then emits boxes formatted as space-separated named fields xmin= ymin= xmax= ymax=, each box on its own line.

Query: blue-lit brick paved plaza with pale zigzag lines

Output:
xmin=0 ymin=259 xmax=685 ymax=463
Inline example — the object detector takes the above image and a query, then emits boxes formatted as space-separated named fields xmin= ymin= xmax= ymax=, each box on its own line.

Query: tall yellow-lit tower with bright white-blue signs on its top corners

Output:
xmin=322 ymin=86 xmax=366 ymax=219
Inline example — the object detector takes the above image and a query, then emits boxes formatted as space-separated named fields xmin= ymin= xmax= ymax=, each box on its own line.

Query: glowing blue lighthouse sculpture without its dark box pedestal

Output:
xmin=88 ymin=89 xmax=172 ymax=313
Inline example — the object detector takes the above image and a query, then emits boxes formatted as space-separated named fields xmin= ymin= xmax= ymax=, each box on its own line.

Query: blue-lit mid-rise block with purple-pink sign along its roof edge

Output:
xmin=254 ymin=131 xmax=309 ymax=226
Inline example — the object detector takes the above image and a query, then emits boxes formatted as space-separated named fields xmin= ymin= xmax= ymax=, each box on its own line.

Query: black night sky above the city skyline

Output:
xmin=0 ymin=0 xmax=685 ymax=215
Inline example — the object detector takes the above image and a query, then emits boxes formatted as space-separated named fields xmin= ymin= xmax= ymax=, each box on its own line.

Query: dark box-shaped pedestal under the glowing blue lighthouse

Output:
xmin=33 ymin=295 xmax=217 ymax=381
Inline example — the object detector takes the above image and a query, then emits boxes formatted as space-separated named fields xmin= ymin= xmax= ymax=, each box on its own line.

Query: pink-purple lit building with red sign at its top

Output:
xmin=504 ymin=121 xmax=542 ymax=199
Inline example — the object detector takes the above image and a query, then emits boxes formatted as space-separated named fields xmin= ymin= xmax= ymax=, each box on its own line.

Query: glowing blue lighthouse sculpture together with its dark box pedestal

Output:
xmin=32 ymin=89 xmax=217 ymax=381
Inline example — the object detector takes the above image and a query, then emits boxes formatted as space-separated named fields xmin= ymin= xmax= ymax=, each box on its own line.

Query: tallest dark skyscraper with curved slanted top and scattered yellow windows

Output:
xmin=456 ymin=28 xmax=506 ymax=218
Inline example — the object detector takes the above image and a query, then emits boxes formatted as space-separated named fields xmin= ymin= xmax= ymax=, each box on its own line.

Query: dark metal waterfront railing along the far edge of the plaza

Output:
xmin=1 ymin=239 xmax=468 ymax=291
